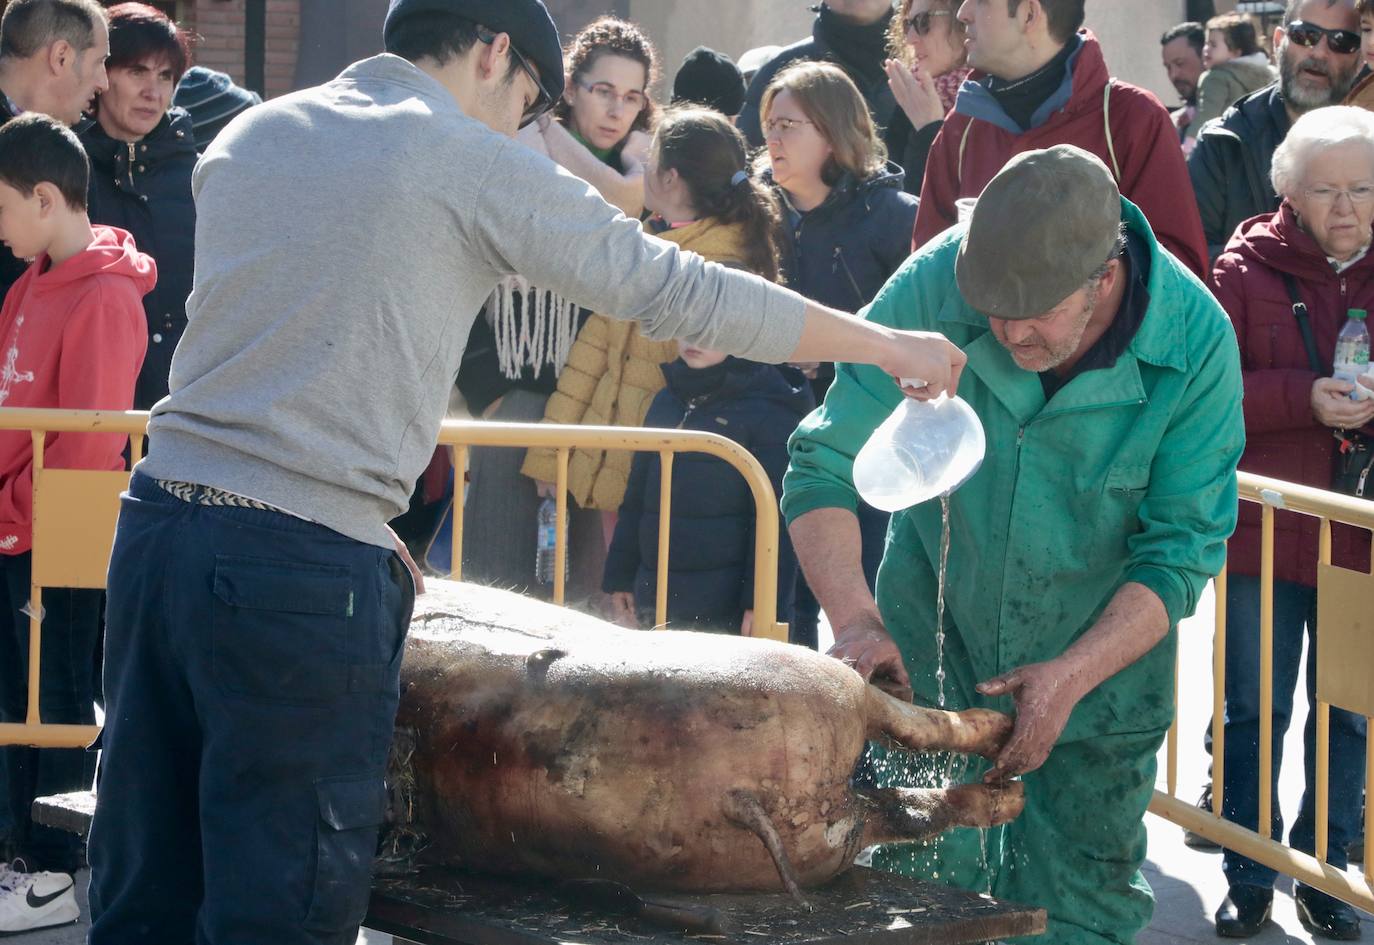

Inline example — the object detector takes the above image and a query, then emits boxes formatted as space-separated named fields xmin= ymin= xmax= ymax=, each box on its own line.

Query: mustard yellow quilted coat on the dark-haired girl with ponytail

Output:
xmin=521 ymin=220 xmax=743 ymax=511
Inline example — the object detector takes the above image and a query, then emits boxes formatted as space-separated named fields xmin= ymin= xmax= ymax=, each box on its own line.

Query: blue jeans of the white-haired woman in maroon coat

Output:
xmin=1223 ymin=576 xmax=1366 ymax=887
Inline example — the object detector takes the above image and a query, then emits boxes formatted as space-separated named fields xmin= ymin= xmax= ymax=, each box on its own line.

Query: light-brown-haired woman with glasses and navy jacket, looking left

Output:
xmin=757 ymin=62 xmax=916 ymax=647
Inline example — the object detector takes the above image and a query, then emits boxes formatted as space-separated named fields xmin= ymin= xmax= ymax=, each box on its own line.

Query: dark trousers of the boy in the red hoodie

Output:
xmin=0 ymin=552 xmax=102 ymax=872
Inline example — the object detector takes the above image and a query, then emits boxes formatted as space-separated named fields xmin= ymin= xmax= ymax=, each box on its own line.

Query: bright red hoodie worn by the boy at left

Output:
xmin=0 ymin=227 xmax=158 ymax=555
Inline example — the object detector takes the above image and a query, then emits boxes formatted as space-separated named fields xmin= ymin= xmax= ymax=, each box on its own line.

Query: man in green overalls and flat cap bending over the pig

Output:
xmin=783 ymin=146 xmax=1245 ymax=945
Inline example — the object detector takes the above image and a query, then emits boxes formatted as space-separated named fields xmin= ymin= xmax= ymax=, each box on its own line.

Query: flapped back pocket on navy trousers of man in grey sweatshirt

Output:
xmin=210 ymin=555 xmax=353 ymax=706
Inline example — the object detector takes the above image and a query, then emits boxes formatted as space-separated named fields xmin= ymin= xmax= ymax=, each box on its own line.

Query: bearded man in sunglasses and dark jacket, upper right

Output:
xmin=1189 ymin=0 xmax=1360 ymax=260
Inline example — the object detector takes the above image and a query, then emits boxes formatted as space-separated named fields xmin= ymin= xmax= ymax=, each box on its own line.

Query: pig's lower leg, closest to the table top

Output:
xmin=859 ymin=782 xmax=1025 ymax=846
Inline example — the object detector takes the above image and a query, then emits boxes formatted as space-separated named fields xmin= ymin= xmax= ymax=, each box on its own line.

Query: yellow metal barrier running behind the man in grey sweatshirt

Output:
xmin=0 ymin=408 xmax=787 ymax=747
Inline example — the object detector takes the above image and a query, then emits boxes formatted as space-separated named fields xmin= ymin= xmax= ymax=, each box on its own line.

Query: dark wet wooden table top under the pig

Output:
xmin=364 ymin=867 xmax=1046 ymax=945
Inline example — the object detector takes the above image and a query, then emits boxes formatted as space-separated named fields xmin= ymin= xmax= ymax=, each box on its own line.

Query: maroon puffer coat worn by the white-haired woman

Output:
xmin=1212 ymin=202 xmax=1374 ymax=587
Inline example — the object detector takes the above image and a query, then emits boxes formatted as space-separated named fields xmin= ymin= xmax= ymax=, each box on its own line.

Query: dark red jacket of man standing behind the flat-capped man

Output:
xmin=912 ymin=30 xmax=1208 ymax=279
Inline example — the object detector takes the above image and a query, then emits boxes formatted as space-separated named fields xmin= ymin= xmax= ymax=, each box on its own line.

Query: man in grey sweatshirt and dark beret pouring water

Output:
xmin=89 ymin=0 xmax=963 ymax=945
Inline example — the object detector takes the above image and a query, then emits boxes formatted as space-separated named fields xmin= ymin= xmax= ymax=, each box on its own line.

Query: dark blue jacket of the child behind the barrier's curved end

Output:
xmin=603 ymin=357 xmax=815 ymax=632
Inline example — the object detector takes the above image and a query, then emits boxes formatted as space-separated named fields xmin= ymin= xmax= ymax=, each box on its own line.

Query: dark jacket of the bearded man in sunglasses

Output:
xmin=1189 ymin=82 xmax=1290 ymax=262
